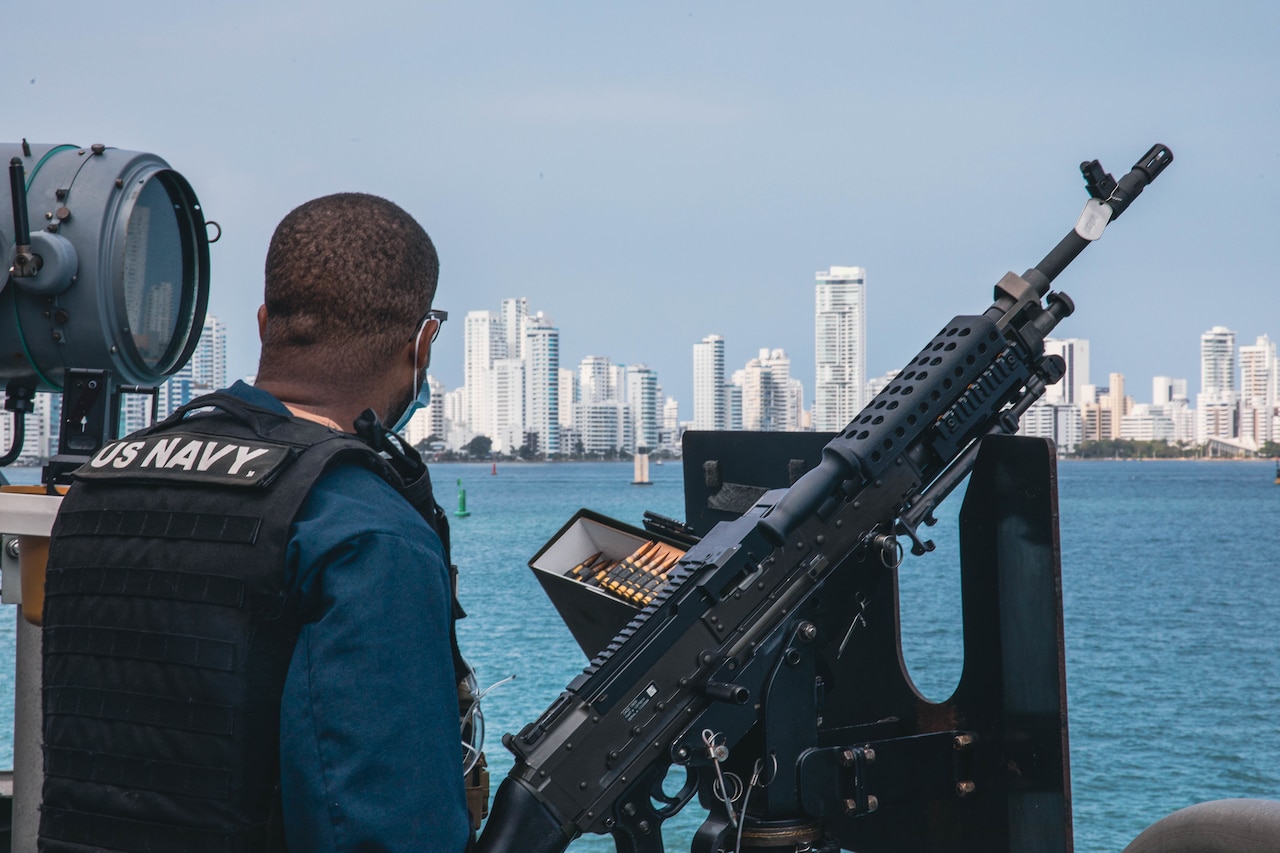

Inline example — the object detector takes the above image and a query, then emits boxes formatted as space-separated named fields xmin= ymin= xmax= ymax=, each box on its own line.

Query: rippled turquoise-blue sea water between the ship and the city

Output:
xmin=0 ymin=461 xmax=1280 ymax=853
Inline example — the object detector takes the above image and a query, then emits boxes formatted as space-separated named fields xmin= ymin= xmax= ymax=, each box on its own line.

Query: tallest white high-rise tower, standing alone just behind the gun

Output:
xmin=813 ymin=266 xmax=867 ymax=432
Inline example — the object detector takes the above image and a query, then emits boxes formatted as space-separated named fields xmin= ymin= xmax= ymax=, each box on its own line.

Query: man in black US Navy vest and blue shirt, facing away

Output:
xmin=40 ymin=193 xmax=471 ymax=853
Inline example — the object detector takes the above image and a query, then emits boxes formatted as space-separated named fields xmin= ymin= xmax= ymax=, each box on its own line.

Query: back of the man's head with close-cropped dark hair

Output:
xmin=262 ymin=192 xmax=440 ymax=382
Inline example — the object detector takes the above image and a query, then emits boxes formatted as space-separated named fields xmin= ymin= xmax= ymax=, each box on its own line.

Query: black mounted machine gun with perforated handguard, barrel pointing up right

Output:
xmin=477 ymin=145 xmax=1172 ymax=853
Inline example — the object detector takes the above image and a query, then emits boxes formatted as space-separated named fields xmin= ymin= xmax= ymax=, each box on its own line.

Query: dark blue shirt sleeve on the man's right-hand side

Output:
xmin=280 ymin=467 xmax=470 ymax=853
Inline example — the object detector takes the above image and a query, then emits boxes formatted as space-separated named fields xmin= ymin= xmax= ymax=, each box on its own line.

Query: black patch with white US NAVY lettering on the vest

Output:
xmin=74 ymin=433 xmax=294 ymax=485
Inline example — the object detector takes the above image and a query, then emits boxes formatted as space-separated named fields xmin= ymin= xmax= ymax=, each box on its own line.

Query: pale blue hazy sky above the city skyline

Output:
xmin=0 ymin=0 xmax=1280 ymax=419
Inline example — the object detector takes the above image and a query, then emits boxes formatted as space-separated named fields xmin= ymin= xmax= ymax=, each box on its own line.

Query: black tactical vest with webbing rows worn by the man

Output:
xmin=40 ymin=394 xmax=458 ymax=853
